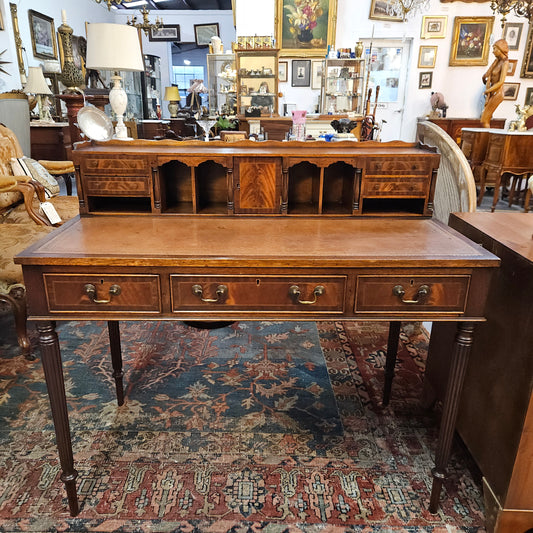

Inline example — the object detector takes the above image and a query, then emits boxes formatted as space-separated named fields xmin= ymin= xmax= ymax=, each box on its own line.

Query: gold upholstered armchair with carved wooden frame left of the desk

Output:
xmin=0 ymin=122 xmax=79 ymax=359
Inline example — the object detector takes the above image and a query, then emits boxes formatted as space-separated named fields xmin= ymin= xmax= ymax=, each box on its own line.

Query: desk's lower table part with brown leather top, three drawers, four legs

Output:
xmin=16 ymin=215 xmax=499 ymax=515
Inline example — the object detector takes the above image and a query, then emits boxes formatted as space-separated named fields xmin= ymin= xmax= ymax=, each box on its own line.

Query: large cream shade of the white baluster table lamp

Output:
xmin=85 ymin=23 xmax=144 ymax=71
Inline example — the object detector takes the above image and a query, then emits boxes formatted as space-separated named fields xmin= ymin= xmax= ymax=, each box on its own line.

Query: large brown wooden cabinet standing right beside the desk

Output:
xmin=426 ymin=212 xmax=533 ymax=533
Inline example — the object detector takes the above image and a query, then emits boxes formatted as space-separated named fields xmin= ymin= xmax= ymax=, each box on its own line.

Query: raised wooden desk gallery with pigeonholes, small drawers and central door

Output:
xmin=72 ymin=140 xmax=440 ymax=217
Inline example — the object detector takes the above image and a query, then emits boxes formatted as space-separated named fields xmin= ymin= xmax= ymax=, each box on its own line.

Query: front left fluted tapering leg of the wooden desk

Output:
xmin=37 ymin=322 xmax=79 ymax=516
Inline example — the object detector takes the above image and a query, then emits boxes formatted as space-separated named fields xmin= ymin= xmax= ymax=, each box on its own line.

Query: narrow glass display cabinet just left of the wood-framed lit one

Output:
xmin=207 ymin=54 xmax=237 ymax=115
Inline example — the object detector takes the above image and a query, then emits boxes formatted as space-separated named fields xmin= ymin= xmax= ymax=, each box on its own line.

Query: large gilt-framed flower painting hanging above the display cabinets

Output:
xmin=275 ymin=0 xmax=337 ymax=57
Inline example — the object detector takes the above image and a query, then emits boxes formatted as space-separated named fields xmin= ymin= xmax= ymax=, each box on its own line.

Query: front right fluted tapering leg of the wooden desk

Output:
xmin=429 ymin=322 xmax=474 ymax=513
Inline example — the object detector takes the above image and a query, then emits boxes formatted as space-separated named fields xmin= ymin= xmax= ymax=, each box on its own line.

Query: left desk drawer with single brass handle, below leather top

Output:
xmin=44 ymin=274 xmax=161 ymax=313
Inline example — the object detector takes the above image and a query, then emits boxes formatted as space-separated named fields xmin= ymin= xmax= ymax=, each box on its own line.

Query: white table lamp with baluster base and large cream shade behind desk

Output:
xmin=86 ymin=23 xmax=144 ymax=139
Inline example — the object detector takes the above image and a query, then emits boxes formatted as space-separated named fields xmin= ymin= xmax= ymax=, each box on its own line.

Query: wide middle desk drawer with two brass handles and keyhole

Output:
xmin=170 ymin=275 xmax=346 ymax=314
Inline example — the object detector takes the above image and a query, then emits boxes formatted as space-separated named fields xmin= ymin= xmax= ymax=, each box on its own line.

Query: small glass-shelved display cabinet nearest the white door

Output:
xmin=322 ymin=59 xmax=365 ymax=114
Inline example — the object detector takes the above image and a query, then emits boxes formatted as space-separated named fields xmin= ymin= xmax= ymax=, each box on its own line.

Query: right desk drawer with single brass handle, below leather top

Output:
xmin=354 ymin=275 xmax=470 ymax=313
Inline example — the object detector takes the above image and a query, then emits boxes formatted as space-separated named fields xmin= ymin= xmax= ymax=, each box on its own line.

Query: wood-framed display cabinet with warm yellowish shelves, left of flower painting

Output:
xmin=235 ymin=48 xmax=279 ymax=116
